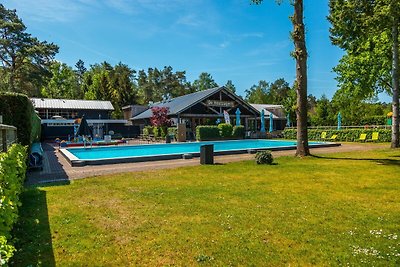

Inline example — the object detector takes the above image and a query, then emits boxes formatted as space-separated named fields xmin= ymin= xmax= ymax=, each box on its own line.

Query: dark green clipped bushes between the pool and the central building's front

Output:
xmin=196 ymin=123 xmax=245 ymax=141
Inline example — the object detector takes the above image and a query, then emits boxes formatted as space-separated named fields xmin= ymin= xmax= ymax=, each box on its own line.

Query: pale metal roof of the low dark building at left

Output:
xmin=31 ymin=98 xmax=114 ymax=110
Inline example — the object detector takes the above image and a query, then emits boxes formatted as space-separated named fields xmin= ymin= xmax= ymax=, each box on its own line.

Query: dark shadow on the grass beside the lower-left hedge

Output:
xmin=11 ymin=187 xmax=55 ymax=266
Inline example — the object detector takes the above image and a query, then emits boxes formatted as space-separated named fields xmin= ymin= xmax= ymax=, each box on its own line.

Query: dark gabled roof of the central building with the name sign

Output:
xmin=132 ymin=86 xmax=259 ymax=120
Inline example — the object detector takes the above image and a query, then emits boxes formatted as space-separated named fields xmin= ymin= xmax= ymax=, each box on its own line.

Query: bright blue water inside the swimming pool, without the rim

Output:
xmin=67 ymin=139 xmax=321 ymax=160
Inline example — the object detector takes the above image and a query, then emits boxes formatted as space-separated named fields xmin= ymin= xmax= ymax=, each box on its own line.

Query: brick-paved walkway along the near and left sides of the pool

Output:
xmin=26 ymin=143 xmax=389 ymax=185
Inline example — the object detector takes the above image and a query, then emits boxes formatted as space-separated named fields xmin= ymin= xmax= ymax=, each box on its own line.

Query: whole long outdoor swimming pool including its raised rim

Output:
xmin=60 ymin=139 xmax=340 ymax=166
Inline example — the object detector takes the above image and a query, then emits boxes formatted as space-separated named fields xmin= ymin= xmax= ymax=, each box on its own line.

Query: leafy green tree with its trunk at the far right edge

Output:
xmin=328 ymin=0 xmax=400 ymax=148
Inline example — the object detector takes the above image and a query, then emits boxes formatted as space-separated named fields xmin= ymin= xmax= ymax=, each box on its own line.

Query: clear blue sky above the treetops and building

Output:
xmin=3 ymin=0 xmax=352 ymax=97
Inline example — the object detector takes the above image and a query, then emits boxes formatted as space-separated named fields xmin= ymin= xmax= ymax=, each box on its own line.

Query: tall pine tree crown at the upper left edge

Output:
xmin=0 ymin=4 xmax=58 ymax=95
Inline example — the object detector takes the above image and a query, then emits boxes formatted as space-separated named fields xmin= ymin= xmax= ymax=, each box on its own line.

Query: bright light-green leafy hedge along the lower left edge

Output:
xmin=0 ymin=144 xmax=27 ymax=265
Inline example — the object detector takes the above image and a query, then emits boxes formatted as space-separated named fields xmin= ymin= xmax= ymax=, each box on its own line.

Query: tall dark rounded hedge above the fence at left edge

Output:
xmin=0 ymin=93 xmax=41 ymax=146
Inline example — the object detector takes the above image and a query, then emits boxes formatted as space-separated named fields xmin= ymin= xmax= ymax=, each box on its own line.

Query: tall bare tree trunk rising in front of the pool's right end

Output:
xmin=292 ymin=0 xmax=310 ymax=157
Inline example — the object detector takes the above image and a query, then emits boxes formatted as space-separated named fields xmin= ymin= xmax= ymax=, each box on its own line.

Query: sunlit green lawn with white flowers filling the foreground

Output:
xmin=10 ymin=150 xmax=400 ymax=266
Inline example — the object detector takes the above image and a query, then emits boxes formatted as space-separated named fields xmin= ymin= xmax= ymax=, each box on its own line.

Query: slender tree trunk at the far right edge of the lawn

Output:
xmin=390 ymin=12 xmax=399 ymax=148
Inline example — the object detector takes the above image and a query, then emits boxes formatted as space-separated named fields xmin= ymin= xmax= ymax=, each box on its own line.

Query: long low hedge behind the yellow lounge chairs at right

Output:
xmin=283 ymin=128 xmax=392 ymax=142
